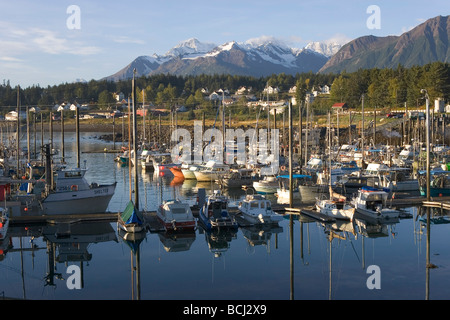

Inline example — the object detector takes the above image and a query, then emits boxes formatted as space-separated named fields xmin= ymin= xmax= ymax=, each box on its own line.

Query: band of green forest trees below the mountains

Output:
xmin=0 ymin=62 xmax=450 ymax=114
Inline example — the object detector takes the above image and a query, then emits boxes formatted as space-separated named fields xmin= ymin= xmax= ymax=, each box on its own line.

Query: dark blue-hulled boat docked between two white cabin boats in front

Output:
xmin=199 ymin=190 xmax=238 ymax=231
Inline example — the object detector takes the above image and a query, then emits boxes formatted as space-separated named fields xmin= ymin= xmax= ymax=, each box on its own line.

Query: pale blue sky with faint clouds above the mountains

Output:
xmin=0 ymin=0 xmax=450 ymax=87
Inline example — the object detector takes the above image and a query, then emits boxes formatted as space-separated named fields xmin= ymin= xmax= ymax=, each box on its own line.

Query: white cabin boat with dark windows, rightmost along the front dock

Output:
xmin=352 ymin=187 xmax=400 ymax=220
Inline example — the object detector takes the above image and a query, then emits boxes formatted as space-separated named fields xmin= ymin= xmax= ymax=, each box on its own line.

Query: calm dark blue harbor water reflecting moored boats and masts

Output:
xmin=0 ymin=134 xmax=450 ymax=300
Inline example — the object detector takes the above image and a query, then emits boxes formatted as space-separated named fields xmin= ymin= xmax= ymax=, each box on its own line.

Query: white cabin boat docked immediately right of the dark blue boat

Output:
xmin=238 ymin=194 xmax=283 ymax=224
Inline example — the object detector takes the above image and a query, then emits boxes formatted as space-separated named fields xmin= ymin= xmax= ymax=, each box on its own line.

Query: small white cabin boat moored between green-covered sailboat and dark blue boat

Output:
xmin=156 ymin=200 xmax=197 ymax=232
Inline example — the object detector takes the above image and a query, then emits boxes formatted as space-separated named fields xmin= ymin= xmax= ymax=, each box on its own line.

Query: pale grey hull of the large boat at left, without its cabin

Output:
xmin=42 ymin=183 xmax=116 ymax=214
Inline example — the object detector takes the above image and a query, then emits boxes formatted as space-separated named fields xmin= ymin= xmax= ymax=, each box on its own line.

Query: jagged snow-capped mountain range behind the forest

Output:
xmin=106 ymin=37 xmax=337 ymax=81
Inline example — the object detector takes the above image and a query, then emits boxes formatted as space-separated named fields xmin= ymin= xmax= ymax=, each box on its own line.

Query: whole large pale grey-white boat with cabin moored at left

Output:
xmin=41 ymin=168 xmax=116 ymax=214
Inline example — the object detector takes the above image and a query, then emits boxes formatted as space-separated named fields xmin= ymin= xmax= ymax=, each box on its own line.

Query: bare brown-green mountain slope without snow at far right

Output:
xmin=319 ymin=16 xmax=450 ymax=73
